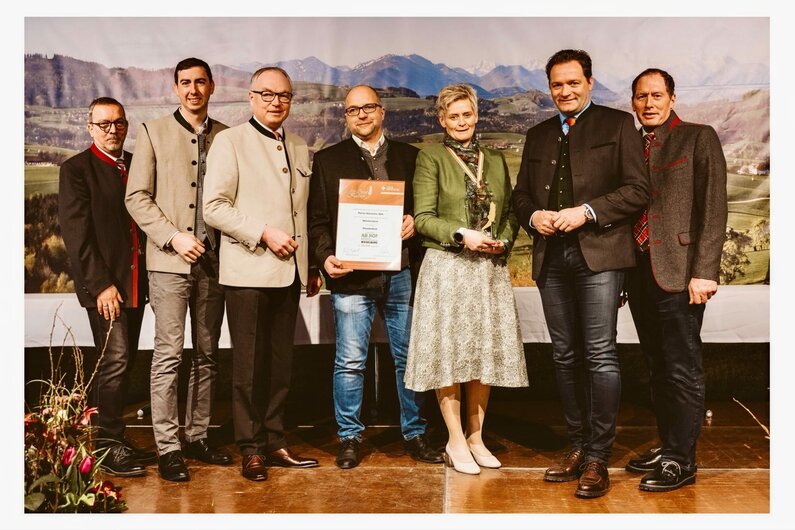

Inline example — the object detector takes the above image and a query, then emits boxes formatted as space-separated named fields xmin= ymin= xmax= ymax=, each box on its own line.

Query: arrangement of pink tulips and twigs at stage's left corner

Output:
xmin=25 ymin=311 xmax=127 ymax=513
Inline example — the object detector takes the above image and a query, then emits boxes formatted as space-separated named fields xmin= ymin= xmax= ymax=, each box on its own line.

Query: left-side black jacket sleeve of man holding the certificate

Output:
xmin=308 ymin=155 xmax=336 ymax=268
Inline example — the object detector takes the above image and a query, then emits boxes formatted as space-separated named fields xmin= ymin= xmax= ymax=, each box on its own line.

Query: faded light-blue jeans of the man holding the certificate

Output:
xmin=331 ymin=267 xmax=425 ymax=441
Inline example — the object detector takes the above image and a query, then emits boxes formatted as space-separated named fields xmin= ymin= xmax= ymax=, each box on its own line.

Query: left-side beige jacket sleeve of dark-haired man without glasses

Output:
xmin=124 ymin=124 xmax=179 ymax=248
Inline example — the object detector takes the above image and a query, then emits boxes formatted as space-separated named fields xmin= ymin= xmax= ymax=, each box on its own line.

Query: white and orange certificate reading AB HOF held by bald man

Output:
xmin=336 ymin=179 xmax=405 ymax=271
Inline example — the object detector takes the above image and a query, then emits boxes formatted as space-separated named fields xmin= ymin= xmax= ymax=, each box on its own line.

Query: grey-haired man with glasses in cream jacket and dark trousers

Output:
xmin=204 ymin=67 xmax=320 ymax=480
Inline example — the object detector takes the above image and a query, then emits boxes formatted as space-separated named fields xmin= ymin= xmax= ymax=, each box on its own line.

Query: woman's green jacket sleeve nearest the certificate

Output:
xmin=413 ymin=146 xmax=461 ymax=241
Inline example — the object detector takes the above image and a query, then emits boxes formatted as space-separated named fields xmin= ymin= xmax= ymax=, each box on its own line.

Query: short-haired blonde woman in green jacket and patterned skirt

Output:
xmin=405 ymin=84 xmax=527 ymax=474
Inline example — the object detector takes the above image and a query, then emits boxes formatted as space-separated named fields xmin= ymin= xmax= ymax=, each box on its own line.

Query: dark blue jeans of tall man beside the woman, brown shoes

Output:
xmin=538 ymin=235 xmax=624 ymax=464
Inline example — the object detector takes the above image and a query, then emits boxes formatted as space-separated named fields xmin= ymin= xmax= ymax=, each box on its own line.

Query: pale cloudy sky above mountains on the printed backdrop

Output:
xmin=25 ymin=17 xmax=770 ymax=85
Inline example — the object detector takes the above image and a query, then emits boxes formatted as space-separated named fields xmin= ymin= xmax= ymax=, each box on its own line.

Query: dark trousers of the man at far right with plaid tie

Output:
xmin=627 ymin=254 xmax=705 ymax=468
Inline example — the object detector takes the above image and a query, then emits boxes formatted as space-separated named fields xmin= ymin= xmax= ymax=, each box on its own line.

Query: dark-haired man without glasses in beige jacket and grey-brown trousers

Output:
xmin=125 ymin=57 xmax=232 ymax=482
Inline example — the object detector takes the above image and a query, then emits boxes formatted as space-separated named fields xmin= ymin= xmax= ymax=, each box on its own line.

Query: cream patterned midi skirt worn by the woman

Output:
xmin=405 ymin=245 xmax=528 ymax=392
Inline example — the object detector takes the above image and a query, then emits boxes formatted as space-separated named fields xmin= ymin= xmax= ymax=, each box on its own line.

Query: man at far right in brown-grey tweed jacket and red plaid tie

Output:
xmin=627 ymin=68 xmax=727 ymax=491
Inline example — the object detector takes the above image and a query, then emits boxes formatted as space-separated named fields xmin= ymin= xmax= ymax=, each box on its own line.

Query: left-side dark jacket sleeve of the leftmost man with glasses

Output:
xmin=58 ymin=162 xmax=113 ymax=298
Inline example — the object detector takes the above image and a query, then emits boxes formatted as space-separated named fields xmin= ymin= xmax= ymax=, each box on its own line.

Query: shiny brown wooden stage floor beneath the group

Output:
xmin=111 ymin=401 xmax=770 ymax=514
